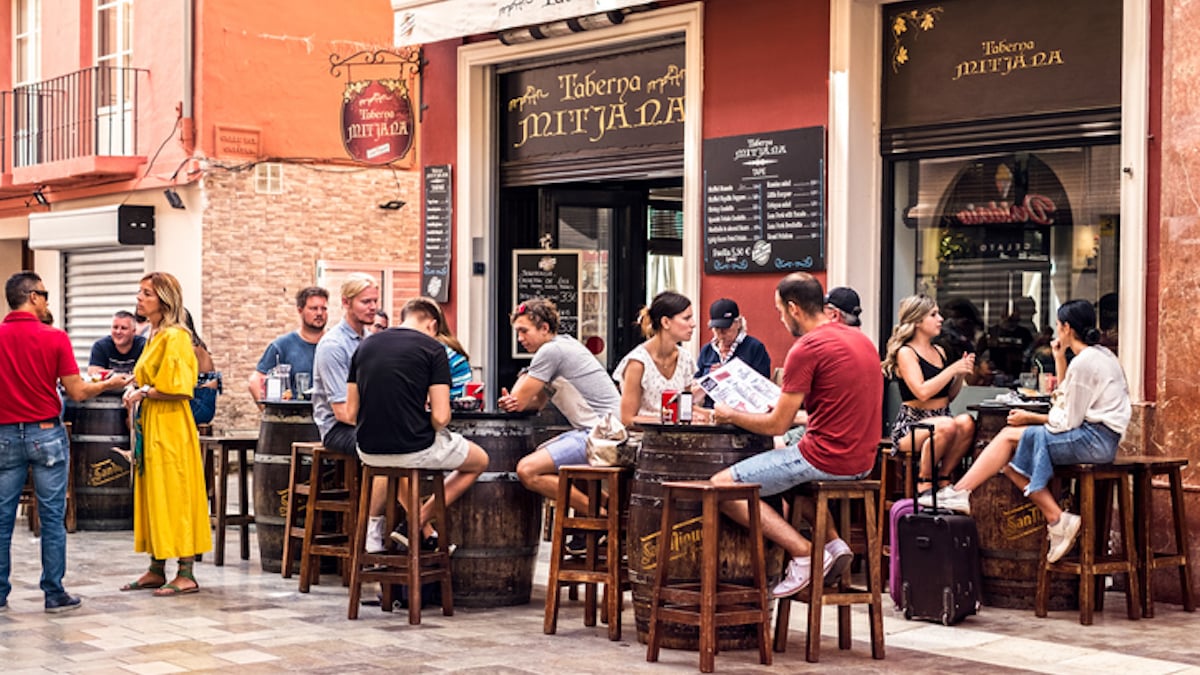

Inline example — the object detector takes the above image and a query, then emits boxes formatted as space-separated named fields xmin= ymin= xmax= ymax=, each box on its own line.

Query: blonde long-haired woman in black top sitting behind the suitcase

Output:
xmin=883 ymin=295 xmax=974 ymax=490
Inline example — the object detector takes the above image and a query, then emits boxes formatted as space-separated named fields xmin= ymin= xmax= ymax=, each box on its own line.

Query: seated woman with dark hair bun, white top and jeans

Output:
xmin=922 ymin=300 xmax=1132 ymax=562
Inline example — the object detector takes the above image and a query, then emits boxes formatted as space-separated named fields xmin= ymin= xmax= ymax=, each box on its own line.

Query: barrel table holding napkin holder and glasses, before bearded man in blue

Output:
xmin=254 ymin=401 xmax=320 ymax=573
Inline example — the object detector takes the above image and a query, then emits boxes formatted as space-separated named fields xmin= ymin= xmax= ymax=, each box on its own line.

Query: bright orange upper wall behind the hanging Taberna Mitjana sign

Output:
xmin=197 ymin=0 xmax=398 ymax=159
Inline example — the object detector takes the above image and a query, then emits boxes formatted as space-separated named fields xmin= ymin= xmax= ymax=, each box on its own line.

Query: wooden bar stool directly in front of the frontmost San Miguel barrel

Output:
xmin=646 ymin=480 xmax=770 ymax=673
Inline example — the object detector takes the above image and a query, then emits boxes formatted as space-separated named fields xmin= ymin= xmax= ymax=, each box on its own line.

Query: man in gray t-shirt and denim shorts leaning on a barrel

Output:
xmin=499 ymin=298 xmax=620 ymax=509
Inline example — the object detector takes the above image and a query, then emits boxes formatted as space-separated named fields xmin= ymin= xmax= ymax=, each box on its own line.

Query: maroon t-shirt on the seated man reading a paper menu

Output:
xmin=782 ymin=323 xmax=883 ymax=476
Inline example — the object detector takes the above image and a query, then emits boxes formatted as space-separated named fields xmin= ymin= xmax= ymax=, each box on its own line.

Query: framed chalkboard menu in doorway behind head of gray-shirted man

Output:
xmin=512 ymin=249 xmax=582 ymax=358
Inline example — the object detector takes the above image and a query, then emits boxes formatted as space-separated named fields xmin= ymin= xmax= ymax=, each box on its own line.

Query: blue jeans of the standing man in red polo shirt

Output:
xmin=0 ymin=419 xmax=71 ymax=602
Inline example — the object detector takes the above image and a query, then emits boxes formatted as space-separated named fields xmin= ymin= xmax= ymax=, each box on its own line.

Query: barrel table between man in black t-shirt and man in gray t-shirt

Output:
xmin=440 ymin=411 xmax=541 ymax=607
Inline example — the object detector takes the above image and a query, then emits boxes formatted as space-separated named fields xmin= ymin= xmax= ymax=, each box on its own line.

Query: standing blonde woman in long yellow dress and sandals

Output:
xmin=121 ymin=271 xmax=212 ymax=596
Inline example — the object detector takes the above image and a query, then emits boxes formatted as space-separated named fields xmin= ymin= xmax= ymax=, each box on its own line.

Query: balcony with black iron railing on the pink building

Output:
xmin=0 ymin=66 xmax=148 ymax=187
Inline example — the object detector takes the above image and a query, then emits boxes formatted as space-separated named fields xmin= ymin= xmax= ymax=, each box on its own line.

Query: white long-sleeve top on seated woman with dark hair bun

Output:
xmin=1046 ymin=345 xmax=1133 ymax=435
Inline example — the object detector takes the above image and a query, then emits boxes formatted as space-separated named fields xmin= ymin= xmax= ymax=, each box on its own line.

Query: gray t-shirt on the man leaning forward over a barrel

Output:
xmin=528 ymin=335 xmax=620 ymax=429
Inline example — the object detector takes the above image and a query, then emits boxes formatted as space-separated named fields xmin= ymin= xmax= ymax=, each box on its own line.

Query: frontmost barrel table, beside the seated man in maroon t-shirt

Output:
xmin=626 ymin=424 xmax=781 ymax=650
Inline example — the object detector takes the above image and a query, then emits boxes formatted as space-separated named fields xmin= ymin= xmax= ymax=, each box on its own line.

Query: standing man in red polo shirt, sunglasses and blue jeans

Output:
xmin=0 ymin=271 xmax=131 ymax=614
